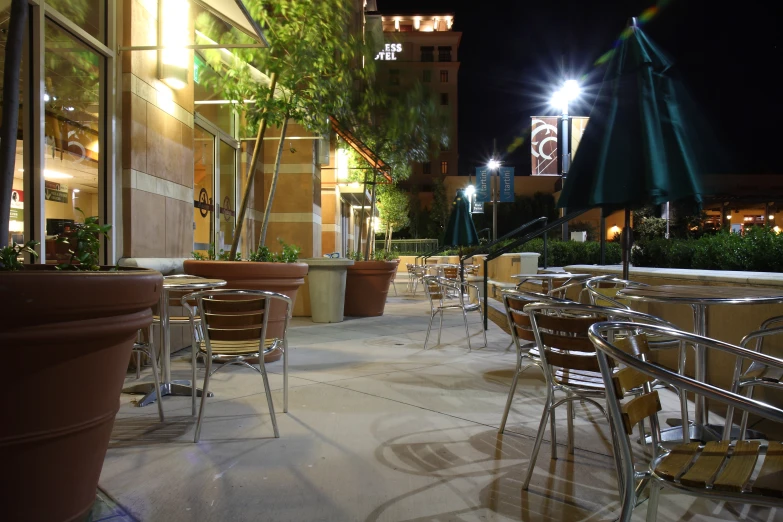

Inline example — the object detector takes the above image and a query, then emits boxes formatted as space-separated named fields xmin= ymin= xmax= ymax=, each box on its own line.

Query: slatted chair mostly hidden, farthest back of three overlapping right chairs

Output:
xmin=498 ymin=290 xmax=568 ymax=433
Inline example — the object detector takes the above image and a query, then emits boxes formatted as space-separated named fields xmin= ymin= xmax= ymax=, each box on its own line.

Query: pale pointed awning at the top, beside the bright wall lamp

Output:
xmin=119 ymin=0 xmax=269 ymax=51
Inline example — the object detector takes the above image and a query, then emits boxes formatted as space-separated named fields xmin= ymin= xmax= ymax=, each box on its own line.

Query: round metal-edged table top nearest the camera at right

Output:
xmin=617 ymin=285 xmax=783 ymax=305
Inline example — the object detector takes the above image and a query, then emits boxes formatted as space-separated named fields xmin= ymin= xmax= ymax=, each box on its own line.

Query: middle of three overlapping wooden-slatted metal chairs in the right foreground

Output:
xmin=522 ymin=303 xmax=673 ymax=489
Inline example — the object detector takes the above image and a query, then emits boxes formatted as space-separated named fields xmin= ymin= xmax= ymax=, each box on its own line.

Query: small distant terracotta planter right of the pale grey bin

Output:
xmin=344 ymin=261 xmax=397 ymax=317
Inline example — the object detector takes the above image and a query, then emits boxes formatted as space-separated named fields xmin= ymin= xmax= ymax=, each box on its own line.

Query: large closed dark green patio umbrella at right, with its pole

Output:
xmin=557 ymin=19 xmax=702 ymax=279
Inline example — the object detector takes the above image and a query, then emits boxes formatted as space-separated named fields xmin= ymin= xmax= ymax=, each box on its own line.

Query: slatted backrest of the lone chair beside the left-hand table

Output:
xmin=182 ymin=289 xmax=292 ymax=352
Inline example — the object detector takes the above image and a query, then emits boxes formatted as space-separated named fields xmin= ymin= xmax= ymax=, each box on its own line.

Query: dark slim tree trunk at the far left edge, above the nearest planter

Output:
xmin=0 ymin=0 xmax=32 ymax=248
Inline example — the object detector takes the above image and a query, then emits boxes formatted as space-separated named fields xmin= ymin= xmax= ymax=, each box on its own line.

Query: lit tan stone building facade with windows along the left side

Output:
xmin=0 ymin=0 xmax=370 ymax=315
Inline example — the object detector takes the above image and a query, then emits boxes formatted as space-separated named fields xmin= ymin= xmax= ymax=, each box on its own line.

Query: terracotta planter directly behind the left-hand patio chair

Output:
xmin=184 ymin=259 xmax=307 ymax=362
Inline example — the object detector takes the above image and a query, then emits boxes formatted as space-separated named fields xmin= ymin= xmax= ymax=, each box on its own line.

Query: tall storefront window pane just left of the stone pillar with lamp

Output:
xmin=44 ymin=20 xmax=104 ymax=263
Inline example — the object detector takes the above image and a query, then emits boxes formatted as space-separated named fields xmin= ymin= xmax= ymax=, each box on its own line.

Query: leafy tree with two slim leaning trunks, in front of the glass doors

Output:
xmin=201 ymin=0 xmax=362 ymax=259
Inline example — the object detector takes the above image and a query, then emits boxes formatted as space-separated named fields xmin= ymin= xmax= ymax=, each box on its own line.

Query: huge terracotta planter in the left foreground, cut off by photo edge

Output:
xmin=0 ymin=265 xmax=163 ymax=521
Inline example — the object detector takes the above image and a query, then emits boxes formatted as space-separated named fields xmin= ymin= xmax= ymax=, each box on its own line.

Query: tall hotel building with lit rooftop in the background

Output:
xmin=366 ymin=2 xmax=462 ymax=191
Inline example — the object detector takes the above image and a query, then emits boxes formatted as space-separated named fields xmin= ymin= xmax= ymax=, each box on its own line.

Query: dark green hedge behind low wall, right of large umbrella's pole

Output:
xmin=631 ymin=227 xmax=783 ymax=272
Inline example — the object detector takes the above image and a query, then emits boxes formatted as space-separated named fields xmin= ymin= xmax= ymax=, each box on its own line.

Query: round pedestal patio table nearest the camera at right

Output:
xmin=617 ymin=285 xmax=783 ymax=440
